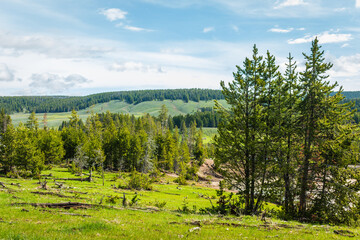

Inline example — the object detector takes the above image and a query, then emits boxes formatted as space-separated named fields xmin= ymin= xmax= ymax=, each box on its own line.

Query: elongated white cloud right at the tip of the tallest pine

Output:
xmin=288 ymin=31 xmax=352 ymax=44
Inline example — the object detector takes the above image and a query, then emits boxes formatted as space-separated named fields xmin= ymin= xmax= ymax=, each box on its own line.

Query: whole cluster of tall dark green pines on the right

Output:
xmin=215 ymin=39 xmax=360 ymax=224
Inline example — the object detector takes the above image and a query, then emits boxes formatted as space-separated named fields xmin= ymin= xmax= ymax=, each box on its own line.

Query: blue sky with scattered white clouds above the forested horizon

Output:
xmin=0 ymin=0 xmax=360 ymax=96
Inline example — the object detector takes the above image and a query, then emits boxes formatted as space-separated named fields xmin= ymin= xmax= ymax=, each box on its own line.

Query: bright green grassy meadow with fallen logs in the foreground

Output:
xmin=0 ymin=168 xmax=360 ymax=239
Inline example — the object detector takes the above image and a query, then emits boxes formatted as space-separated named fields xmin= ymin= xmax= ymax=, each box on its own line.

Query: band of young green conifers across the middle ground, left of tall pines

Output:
xmin=0 ymin=106 xmax=206 ymax=183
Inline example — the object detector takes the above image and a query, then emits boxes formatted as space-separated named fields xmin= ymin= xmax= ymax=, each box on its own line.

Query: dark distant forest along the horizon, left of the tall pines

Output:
xmin=0 ymin=88 xmax=224 ymax=113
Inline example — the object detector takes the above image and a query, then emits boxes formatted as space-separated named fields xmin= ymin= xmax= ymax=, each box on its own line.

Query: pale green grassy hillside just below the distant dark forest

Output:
xmin=11 ymin=100 xmax=227 ymax=127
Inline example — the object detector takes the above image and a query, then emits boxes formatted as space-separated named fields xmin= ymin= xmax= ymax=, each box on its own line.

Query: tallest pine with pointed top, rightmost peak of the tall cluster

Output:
xmin=299 ymin=38 xmax=336 ymax=217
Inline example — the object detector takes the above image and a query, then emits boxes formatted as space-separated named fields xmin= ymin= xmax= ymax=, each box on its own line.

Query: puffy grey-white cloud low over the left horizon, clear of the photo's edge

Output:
xmin=29 ymin=73 xmax=90 ymax=92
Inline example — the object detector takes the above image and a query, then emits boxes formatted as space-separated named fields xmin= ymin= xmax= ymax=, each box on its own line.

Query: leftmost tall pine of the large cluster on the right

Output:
xmin=215 ymin=46 xmax=265 ymax=214
